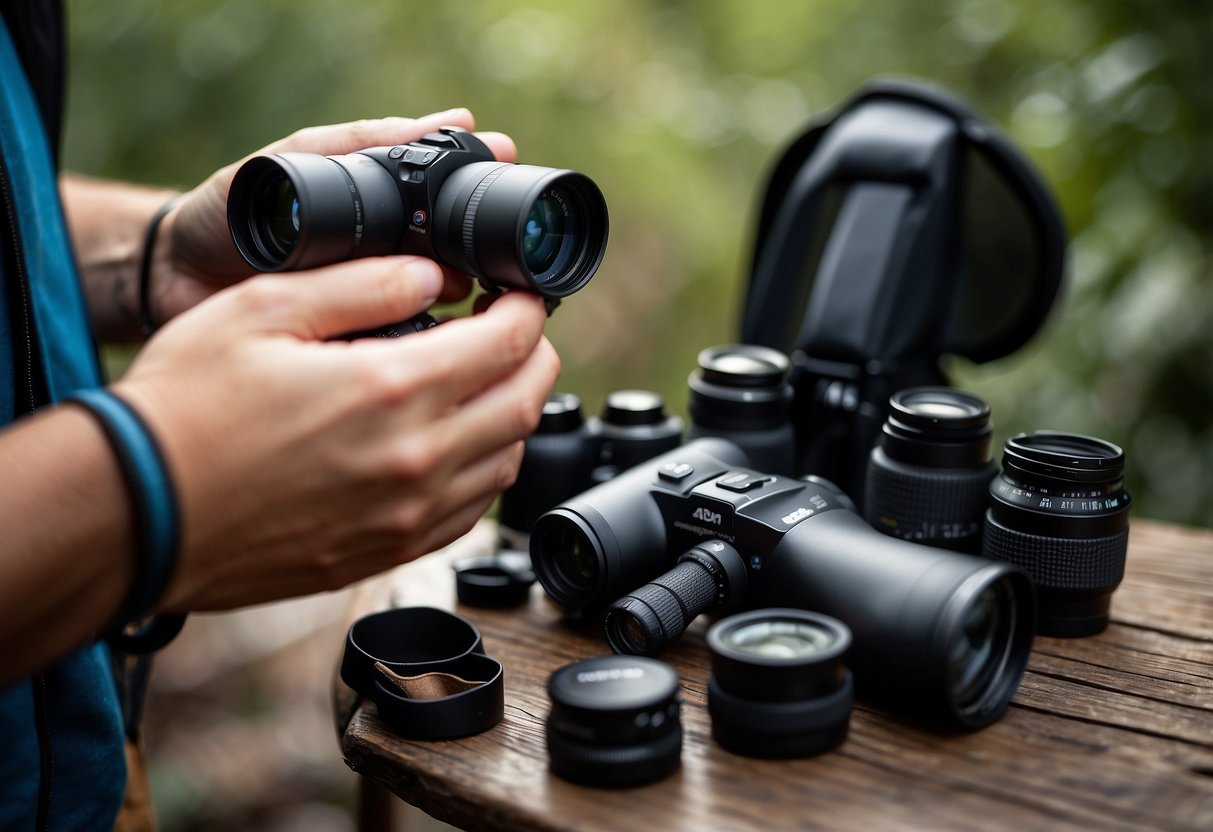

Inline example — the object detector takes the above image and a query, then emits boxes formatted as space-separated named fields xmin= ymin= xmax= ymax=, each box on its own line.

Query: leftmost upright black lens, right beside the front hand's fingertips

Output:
xmin=497 ymin=393 xmax=594 ymax=549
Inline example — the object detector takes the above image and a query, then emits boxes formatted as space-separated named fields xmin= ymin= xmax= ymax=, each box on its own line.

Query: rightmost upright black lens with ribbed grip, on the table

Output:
xmin=983 ymin=431 xmax=1132 ymax=638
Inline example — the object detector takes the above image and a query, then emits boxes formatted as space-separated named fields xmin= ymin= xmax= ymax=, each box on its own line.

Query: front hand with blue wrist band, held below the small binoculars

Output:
xmin=115 ymin=257 xmax=559 ymax=611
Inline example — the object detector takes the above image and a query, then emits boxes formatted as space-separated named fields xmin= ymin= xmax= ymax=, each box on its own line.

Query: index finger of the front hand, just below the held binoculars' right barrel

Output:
xmin=365 ymin=292 xmax=547 ymax=414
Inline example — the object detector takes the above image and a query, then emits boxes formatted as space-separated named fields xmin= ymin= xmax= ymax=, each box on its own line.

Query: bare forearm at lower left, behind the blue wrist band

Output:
xmin=0 ymin=406 xmax=133 ymax=688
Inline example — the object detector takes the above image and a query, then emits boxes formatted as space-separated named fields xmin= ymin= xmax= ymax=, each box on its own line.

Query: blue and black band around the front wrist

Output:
xmin=64 ymin=388 xmax=184 ymax=653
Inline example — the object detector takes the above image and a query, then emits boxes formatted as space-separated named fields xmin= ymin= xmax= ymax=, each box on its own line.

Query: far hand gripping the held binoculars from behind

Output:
xmin=152 ymin=108 xmax=516 ymax=324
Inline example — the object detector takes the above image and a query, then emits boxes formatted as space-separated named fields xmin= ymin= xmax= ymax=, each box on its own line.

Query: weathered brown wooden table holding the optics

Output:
xmin=335 ymin=520 xmax=1213 ymax=832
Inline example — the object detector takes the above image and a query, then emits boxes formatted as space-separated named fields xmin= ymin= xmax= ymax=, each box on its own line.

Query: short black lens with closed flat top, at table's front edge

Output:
xmin=547 ymin=656 xmax=683 ymax=787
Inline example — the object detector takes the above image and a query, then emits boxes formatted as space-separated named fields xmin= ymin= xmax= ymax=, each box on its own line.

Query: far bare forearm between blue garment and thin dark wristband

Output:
xmin=59 ymin=173 xmax=173 ymax=341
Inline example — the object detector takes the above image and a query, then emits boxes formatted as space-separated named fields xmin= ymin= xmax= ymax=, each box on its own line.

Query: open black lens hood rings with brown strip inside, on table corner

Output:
xmin=341 ymin=606 xmax=505 ymax=740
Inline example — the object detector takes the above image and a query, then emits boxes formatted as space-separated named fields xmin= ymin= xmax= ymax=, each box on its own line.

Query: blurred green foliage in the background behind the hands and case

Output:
xmin=66 ymin=0 xmax=1213 ymax=525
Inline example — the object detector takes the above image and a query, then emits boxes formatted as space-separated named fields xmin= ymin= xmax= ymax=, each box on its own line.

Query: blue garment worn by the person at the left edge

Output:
xmin=0 ymin=14 xmax=126 ymax=830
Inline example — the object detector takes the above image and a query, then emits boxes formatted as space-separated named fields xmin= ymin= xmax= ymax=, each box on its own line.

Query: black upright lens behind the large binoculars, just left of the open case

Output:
xmin=687 ymin=344 xmax=796 ymax=477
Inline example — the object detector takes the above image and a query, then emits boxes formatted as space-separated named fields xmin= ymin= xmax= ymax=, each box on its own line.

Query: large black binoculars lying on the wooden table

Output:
xmin=530 ymin=438 xmax=1036 ymax=728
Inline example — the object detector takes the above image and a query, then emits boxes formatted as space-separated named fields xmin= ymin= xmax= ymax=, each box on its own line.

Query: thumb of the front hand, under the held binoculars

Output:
xmin=246 ymin=256 xmax=444 ymax=341
